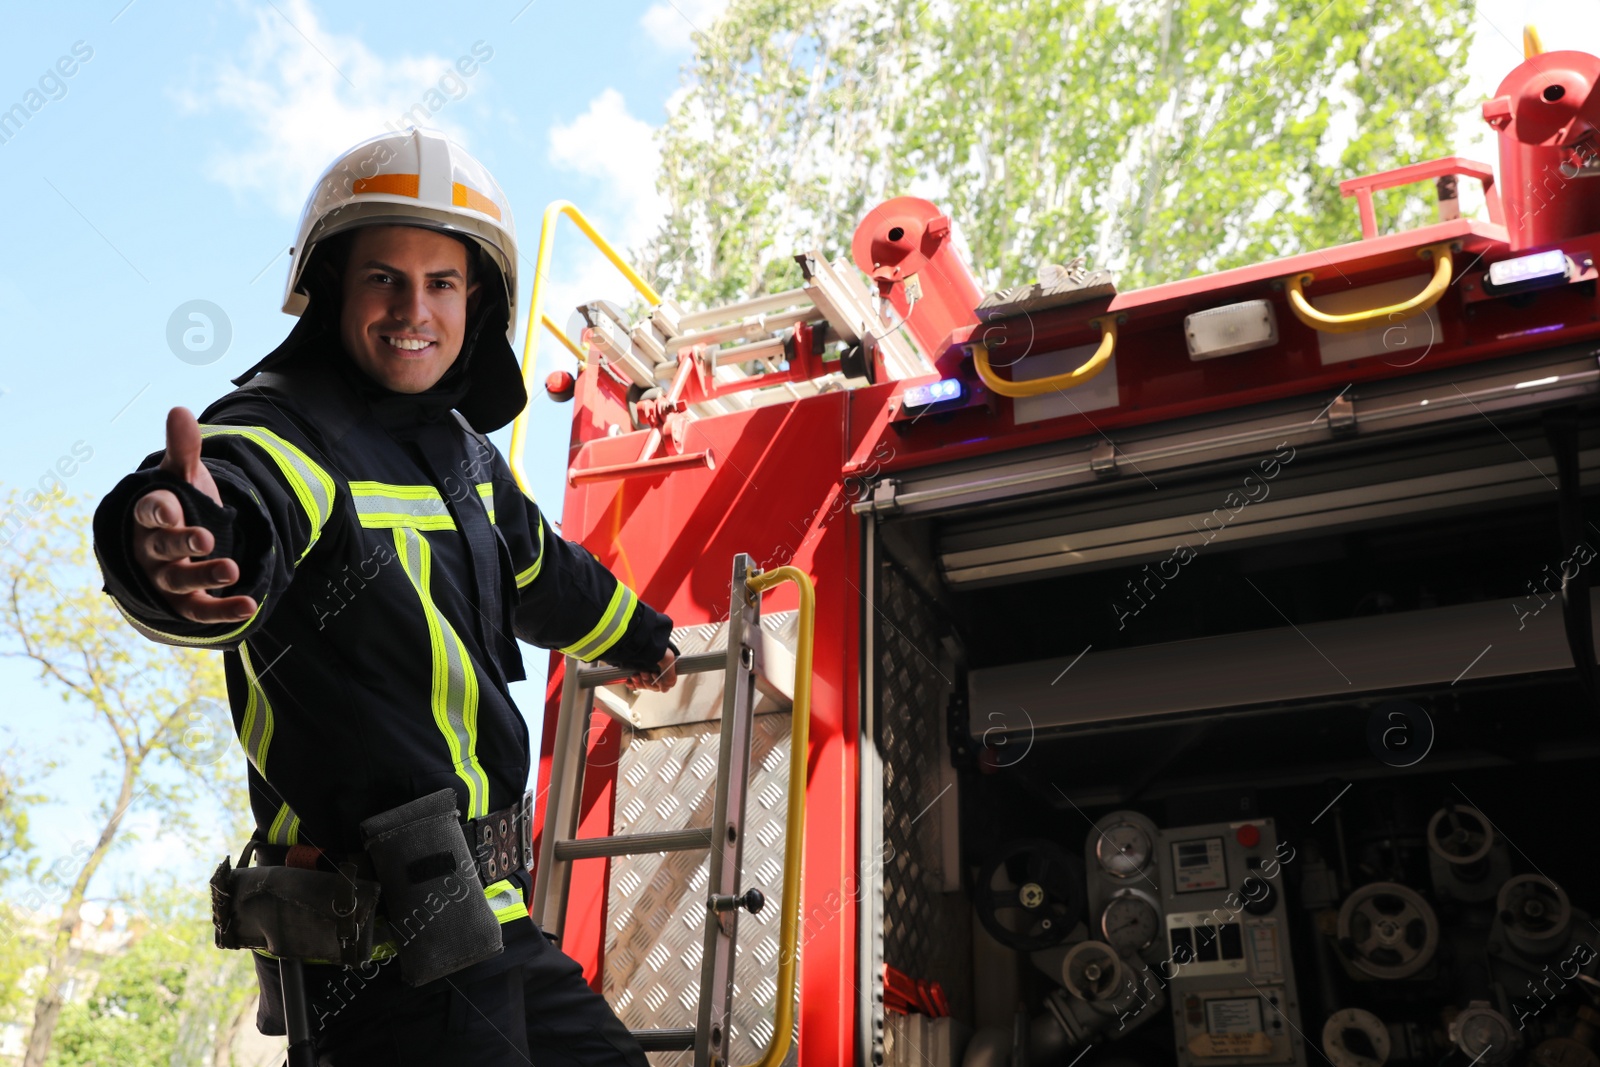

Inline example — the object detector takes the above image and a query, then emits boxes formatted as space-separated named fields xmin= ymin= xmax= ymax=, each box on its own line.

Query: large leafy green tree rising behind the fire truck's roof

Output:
xmin=646 ymin=0 xmax=1472 ymax=306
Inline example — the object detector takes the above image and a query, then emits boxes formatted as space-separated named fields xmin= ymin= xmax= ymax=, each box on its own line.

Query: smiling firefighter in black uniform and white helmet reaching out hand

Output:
xmin=94 ymin=131 xmax=677 ymax=1067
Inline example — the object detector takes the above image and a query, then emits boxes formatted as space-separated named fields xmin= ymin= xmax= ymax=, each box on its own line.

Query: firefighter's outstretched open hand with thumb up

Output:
xmin=133 ymin=408 xmax=256 ymax=622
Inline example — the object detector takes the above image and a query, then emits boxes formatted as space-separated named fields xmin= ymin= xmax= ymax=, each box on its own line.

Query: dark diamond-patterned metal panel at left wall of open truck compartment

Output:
xmin=874 ymin=566 xmax=954 ymax=977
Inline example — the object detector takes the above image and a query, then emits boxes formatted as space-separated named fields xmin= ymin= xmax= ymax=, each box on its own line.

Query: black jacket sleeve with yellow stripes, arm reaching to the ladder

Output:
xmin=493 ymin=454 xmax=672 ymax=670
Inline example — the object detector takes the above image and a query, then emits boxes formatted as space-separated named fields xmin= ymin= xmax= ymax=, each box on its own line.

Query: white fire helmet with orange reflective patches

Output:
xmin=283 ymin=130 xmax=517 ymax=341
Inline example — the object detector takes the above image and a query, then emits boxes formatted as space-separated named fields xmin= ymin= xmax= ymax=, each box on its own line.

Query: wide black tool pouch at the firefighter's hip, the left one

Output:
xmin=211 ymin=841 xmax=379 ymax=966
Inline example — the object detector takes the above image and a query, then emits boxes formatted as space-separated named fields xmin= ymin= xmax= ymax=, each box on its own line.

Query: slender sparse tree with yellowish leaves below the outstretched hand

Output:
xmin=0 ymin=498 xmax=240 ymax=1067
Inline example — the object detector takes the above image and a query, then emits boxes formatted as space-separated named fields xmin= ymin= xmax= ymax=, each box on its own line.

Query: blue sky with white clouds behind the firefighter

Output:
xmin=0 ymin=0 xmax=1600 ymax=894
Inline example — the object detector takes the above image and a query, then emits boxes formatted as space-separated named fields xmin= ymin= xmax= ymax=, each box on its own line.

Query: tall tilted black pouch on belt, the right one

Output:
xmin=362 ymin=789 xmax=502 ymax=985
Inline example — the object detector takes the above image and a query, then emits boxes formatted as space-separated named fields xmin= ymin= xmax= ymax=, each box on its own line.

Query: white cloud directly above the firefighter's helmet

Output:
xmin=179 ymin=0 xmax=483 ymax=218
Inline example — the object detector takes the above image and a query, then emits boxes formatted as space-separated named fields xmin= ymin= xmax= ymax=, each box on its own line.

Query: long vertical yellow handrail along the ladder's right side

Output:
xmin=744 ymin=566 xmax=816 ymax=1067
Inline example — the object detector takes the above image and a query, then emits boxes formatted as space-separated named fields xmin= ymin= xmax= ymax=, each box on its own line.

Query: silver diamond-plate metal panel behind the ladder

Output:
xmin=603 ymin=712 xmax=800 ymax=1067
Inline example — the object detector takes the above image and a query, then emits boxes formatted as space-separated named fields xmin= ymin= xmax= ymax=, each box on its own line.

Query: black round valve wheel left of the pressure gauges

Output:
xmin=973 ymin=838 xmax=1083 ymax=952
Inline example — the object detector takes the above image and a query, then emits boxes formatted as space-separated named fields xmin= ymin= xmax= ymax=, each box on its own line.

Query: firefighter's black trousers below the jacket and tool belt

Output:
xmin=258 ymin=920 xmax=650 ymax=1067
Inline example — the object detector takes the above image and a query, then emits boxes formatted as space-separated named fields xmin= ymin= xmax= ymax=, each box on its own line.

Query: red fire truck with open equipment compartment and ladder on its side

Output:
xmin=512 ymin=38 xmax=1600 ymax=1067
